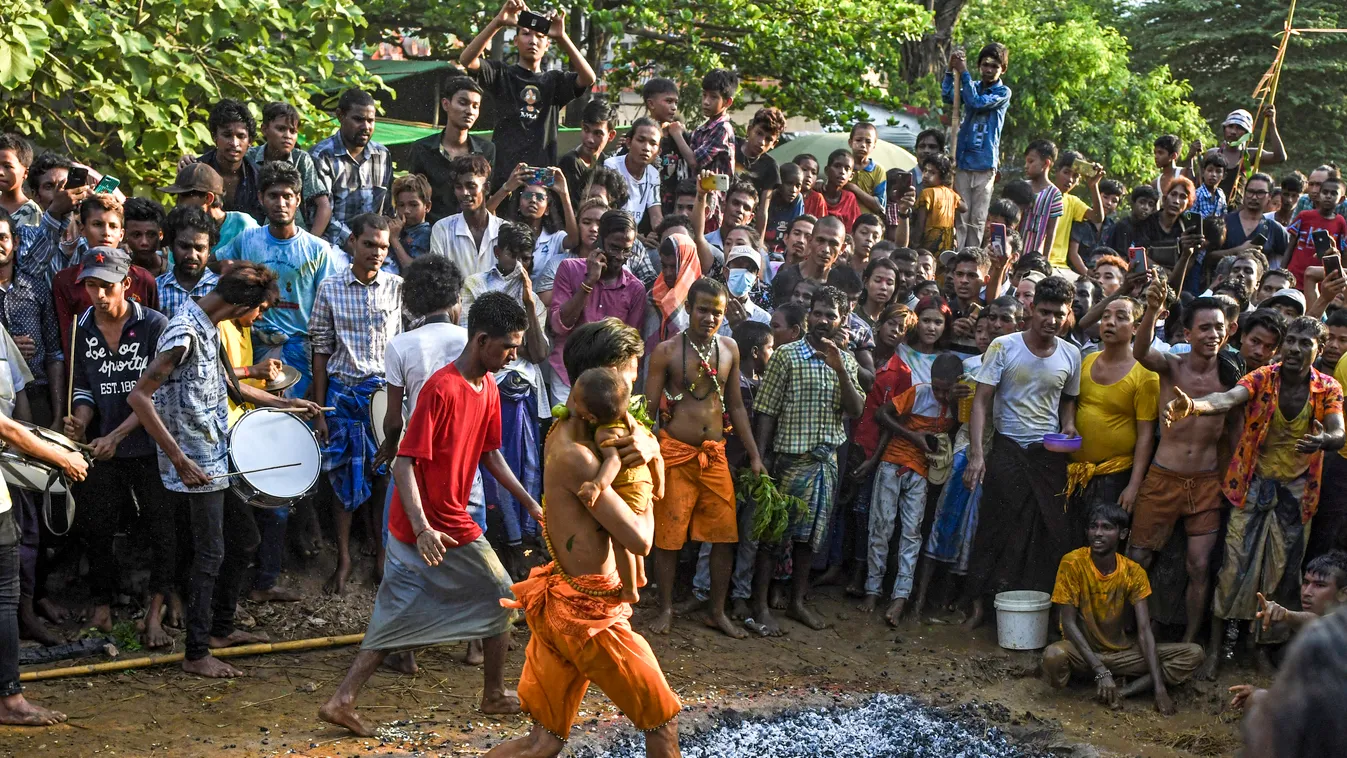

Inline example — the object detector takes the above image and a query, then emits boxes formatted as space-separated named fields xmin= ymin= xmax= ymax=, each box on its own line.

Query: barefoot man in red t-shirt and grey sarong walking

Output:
xmin=318 ymin=292 xmax=543 ymax=736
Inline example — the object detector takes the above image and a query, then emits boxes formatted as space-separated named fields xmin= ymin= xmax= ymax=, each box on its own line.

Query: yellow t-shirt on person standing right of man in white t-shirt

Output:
xmin=1071 ymin=353 xmax=1160 ymax=463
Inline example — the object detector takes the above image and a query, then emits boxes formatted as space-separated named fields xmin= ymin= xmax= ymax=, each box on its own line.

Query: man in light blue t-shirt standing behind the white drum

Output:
xmin=217 ymin=160 xmax=338 ymax=397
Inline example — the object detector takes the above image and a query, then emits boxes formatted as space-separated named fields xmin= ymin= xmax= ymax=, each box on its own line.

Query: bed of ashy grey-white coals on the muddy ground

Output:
xmin=572 ymin=695 xmax=1045 ymax=758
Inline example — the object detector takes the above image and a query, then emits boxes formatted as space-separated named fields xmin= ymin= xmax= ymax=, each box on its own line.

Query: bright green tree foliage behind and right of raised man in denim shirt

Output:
xmin=948 ymin=0 xmax=1210 ymax=184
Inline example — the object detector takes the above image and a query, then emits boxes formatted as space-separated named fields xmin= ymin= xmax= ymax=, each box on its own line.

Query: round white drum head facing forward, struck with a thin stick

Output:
xmin=229 ymin=408 xmax=322 ymax=499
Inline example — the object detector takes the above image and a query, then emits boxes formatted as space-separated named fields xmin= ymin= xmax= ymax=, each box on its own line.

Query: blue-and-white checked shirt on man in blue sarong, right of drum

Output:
xmin=308 ymin=268 xmax=403 ymax=386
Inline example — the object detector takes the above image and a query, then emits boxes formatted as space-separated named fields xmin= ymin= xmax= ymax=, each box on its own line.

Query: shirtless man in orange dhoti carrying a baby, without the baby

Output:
xmin=486 ymin=319 xmax=682 ymax=758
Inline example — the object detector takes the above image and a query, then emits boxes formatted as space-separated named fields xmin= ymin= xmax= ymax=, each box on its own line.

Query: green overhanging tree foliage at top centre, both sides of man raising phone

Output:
xmin=364 ymin=0 xmax=931 ymax=125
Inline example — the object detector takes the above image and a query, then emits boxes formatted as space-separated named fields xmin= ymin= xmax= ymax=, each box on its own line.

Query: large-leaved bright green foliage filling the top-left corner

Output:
xmin=0 ymin=0 xmax=373 ymax=191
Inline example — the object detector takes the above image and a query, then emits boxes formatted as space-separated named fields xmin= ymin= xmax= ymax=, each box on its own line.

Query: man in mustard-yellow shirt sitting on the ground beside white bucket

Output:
xmin=1043 ymin=502 xmax=1203 ymax=716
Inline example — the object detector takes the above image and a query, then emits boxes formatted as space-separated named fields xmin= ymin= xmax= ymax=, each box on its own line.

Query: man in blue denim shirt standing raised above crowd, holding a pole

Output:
xmin=940 ymin=42 xmax=1010 ymax=248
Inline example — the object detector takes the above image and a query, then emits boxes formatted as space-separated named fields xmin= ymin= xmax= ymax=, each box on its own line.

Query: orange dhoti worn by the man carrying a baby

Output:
xmin=501 ymin=562 xmax=683 ymax=740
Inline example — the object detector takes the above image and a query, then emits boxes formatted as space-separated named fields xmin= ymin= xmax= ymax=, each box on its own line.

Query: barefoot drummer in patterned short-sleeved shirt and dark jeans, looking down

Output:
xmin=129 ymin=263 xmax=318 ymax=679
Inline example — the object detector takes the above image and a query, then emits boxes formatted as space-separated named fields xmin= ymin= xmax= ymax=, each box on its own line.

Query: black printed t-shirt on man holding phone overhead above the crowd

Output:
xmin=475 ymin=61 xmax=589 ymax=188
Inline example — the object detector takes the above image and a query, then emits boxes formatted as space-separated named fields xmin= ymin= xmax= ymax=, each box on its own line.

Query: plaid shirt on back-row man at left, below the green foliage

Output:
xmin=308 ymin=132 xmax=393 ymax=246
